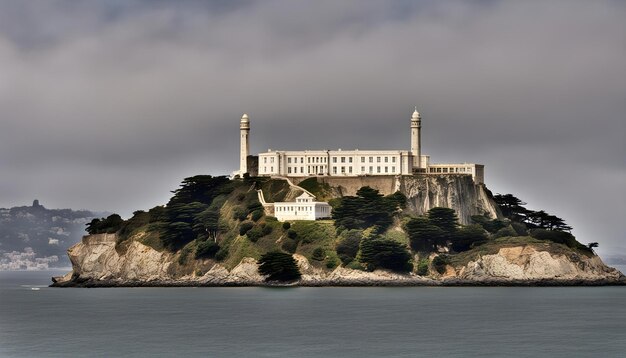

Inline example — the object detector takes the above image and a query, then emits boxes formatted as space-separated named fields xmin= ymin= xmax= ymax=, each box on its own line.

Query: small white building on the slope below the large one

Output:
xmin=274 ymin=193 xmax=332 ymax=221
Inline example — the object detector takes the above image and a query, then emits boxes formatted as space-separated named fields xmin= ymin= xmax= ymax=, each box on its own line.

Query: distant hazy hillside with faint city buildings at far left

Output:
xmin=0 ymin=200 xmax=107 ymax=270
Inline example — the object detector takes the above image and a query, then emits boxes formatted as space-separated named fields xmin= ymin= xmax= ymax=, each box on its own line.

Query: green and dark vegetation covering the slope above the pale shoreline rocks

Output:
xmin=87 ymin=175 xmax=597 ymax=281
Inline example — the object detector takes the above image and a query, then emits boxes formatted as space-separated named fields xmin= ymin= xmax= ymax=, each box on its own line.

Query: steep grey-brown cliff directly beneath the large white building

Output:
xmin=294 ymin=174 xmax=501 ymax=224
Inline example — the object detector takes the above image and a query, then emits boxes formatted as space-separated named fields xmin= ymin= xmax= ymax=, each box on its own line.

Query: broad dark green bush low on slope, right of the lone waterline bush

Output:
xmin=361 ymin=238 xmax=413 ymax=272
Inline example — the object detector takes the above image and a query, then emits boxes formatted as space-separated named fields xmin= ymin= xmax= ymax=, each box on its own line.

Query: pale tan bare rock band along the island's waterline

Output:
xmin=54 ymin=234 xmax=625 ymax=286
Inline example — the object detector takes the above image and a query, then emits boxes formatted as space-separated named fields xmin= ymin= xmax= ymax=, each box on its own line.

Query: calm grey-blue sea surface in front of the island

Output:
xmin=0 ymin=267 xmax=626 ymax=357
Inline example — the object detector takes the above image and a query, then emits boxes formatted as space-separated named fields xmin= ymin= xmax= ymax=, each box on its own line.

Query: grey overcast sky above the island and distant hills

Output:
xmin=0 ymin=0 xmax=626 ymax=255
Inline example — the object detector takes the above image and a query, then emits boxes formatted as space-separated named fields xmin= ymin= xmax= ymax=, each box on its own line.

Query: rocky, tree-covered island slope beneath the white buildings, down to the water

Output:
xmin=55 ymin=176 xmax=623 ymax=286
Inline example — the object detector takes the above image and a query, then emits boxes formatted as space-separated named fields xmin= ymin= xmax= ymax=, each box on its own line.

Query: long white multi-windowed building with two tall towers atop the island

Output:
xmin=236 ymin=108 xmax=484 ymax=183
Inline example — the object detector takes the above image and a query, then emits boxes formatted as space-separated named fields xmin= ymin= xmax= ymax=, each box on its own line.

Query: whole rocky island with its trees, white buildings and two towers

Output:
xmin=53 ymin=108 xmax=625 ymax=287
